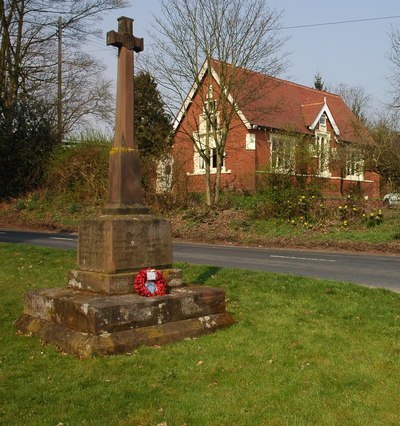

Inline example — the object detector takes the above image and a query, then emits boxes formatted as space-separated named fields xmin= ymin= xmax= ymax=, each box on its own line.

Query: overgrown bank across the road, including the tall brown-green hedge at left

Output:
xmin=0 ymin=137 xmax=400 ymax=253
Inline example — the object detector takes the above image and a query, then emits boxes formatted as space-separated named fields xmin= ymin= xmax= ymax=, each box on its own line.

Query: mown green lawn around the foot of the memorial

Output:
xmin=0 ymin=244 xmax=400 ymax=426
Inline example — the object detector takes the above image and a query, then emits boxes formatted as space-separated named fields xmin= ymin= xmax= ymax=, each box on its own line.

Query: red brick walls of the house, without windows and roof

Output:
xmin=173 ymin=81 xmax=379 ymax=197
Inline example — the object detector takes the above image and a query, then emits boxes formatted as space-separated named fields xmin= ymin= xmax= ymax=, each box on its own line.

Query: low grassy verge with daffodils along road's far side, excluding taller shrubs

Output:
xmin=0 ymin=191 xmax=400 ymax=253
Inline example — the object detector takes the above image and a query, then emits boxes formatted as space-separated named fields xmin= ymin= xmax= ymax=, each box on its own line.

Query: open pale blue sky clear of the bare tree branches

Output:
xmin=89 ymin=0 xmax=400 ymax=115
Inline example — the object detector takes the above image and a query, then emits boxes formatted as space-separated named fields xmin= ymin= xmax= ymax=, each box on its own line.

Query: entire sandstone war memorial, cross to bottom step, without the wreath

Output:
xmin=16 ymin=17 xmax=234 ymax=357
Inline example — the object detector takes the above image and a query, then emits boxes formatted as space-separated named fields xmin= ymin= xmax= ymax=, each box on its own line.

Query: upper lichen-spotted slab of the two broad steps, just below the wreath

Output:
xmin=24 ymin=286 xmax=225 ymax=335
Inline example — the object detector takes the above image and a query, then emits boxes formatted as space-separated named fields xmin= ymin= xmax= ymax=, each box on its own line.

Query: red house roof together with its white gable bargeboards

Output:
xmin=174 ymin=60 xmax=366 ymax=142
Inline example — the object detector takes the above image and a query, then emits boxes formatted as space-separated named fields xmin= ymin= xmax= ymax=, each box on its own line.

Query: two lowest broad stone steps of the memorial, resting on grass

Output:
xmin=16 ymin=286 xmax=234 ymax=357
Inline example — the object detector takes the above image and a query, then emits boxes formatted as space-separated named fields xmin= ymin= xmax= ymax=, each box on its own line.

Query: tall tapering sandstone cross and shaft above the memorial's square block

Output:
xmin=103 ymin=16 xmax=147 ymax=214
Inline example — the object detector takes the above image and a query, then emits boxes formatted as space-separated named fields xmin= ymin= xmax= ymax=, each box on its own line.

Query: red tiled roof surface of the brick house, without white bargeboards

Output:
xmin=213 ymin=61 xmax=366 ymax=142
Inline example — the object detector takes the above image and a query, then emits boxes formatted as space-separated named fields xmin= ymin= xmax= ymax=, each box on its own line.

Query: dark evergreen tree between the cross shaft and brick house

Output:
xmin=134 ymin=71 xmax=172 ymax=155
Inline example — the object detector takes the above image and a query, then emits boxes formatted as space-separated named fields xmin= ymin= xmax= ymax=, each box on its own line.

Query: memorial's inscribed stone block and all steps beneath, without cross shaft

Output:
xmin=16 ymin=213 xmax=234 ymax=357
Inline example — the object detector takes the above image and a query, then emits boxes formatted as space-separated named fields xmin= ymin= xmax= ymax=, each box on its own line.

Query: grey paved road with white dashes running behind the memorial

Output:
xmin=0 ymin=229 xmax=400 ymax=291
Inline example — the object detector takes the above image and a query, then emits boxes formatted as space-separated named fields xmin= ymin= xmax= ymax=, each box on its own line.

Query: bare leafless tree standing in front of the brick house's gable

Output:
xmin=151 ymin=0 xmax=285 ymax=205
